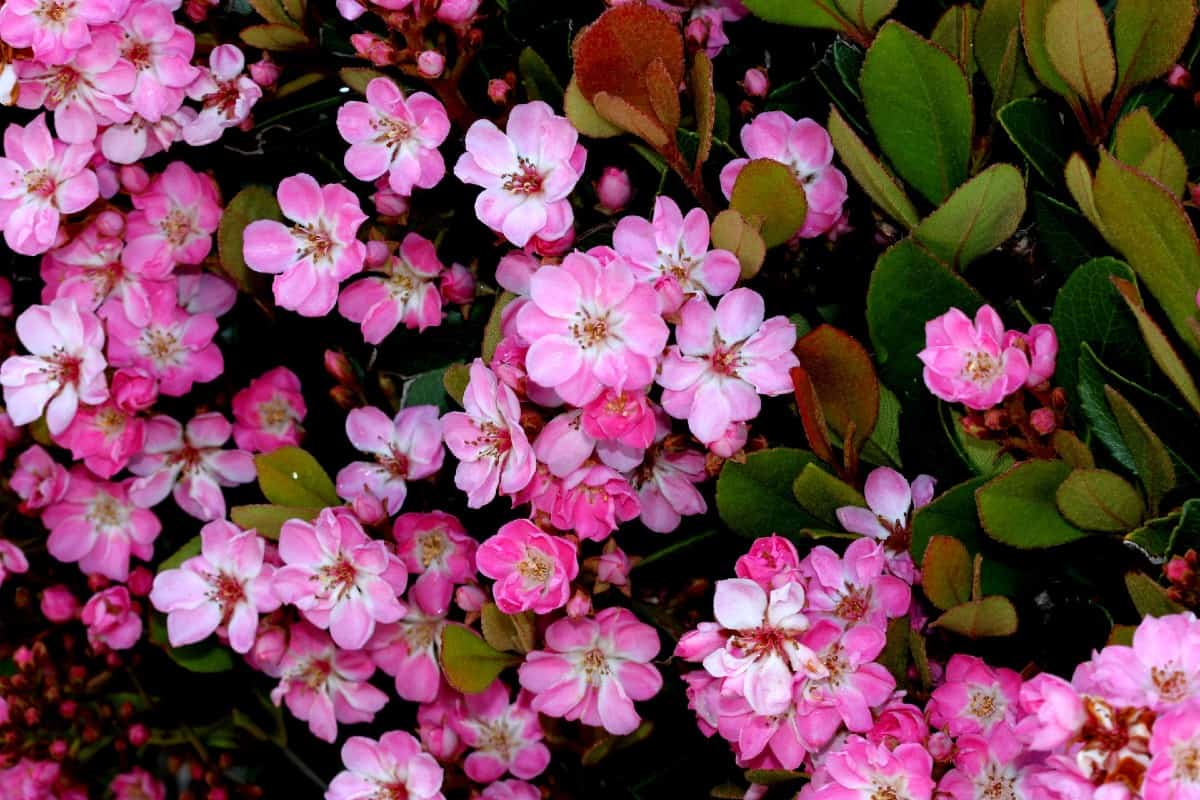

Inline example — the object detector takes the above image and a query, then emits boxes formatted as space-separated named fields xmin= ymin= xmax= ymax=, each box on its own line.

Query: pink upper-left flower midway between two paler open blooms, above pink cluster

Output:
xmin=121 ymin=161 xmax=221 ymax=278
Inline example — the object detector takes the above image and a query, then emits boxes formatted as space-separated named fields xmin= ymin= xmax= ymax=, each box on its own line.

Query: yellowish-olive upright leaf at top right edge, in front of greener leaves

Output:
xmin=1045 ymin=0 xmax=1117 ymax=109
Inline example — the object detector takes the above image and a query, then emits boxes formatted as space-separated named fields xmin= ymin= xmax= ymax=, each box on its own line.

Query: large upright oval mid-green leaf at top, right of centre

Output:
xmin=859 ymin=22 xmax=974 ymax=204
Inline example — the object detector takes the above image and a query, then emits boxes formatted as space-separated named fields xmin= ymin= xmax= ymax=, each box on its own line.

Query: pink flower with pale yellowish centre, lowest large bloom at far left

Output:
xmin=42 ymin=467 xmax=162 ymax=581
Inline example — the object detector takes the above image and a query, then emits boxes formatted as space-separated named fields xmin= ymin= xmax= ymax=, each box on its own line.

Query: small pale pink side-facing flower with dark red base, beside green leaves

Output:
xmin=836 ymin=467 xmax=936 ymax=584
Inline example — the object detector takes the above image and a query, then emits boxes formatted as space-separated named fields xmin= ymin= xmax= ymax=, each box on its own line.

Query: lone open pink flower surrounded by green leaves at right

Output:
xmin=917 ymin=306 xmax=1030 ymax=410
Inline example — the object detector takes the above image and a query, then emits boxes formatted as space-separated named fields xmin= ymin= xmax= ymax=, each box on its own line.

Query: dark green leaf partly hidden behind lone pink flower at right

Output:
xmin=866 ymin=239 xmax=983 ymax=401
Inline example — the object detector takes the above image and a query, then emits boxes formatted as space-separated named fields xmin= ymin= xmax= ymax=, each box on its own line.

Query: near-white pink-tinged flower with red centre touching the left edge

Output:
xmin=0 ymin=300 xmax=108 ymax=434
